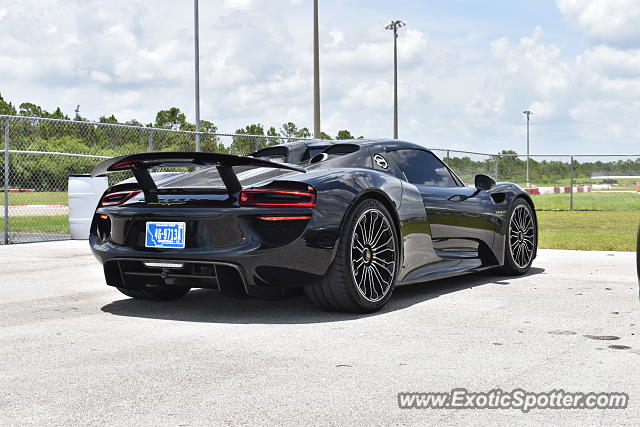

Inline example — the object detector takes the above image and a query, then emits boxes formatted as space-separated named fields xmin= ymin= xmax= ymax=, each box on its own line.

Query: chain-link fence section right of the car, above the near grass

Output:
xmin=433 ymin=150 xmax=640 ymax=211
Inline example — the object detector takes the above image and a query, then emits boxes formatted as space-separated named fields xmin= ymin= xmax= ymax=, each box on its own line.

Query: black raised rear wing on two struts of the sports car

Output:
xmin=91 ymin=151 xmax=306 ymax=202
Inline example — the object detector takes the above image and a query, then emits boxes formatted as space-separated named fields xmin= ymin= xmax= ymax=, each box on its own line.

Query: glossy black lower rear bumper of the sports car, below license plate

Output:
xmin=89 ymin=211 xmax=342 ymax=296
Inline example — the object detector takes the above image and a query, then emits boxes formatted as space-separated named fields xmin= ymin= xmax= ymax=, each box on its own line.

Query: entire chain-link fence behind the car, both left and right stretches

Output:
xmin=0 ymin=115 xmax=640 ymax=243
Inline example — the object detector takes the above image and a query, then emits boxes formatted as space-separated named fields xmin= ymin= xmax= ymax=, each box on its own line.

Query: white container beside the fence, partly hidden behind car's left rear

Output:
xmin=69 ymin=175 xmax=109 ymax=239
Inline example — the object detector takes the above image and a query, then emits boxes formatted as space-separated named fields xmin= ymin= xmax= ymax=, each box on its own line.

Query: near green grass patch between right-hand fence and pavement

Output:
xmin=538 ymin=211 xmax=640 ymax=251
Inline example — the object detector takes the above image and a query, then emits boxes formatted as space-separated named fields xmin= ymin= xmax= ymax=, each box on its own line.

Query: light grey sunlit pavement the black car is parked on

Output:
xmin=0 ymin=241 xmax=640 ymax=426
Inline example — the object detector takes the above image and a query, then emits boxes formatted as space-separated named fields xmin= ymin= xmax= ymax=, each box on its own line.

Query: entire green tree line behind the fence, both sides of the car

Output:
xmin=0 ymin=95 xmax=640 ymax=190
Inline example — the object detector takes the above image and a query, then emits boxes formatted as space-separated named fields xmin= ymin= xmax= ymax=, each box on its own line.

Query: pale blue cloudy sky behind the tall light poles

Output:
xmin=0 ymin=0 xmax=640 ymax=154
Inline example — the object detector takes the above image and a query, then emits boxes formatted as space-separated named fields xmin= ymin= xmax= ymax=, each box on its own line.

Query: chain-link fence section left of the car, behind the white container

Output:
xmin=0 ymin=115 xmax=310 ymax=243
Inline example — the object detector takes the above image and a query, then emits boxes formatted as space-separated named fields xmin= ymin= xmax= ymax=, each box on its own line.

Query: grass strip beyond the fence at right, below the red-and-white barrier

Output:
xmin=531 ymin=192 xmax=640 ymax=210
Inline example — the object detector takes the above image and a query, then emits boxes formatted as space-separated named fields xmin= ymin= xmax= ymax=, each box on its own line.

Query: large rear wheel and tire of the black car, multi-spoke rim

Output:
xmin=305 ymin=199 xmax=399 ymax=313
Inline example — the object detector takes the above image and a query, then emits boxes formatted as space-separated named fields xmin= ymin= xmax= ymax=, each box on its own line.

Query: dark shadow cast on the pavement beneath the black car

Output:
xmin=102 ymin=267 xmax=545 ymax=324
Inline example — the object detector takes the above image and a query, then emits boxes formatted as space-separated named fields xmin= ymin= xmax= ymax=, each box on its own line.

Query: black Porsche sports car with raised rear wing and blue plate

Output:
xmin=90 ymin=140 xmax=537 ymax=312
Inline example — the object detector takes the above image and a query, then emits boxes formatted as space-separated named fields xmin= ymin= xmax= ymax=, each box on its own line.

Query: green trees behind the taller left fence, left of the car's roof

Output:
xmin=0 ymin=94 xmax=363 ymax=191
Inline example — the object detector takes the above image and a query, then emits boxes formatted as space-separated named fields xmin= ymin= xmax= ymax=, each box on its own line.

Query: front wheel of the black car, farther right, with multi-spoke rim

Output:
xmin=502 ymin=198 xmax=538 ymax=276
